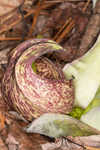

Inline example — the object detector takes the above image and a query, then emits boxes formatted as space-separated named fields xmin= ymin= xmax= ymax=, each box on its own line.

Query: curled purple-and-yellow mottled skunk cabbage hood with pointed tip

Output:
xmin=2 ymin=39 xmax=74 ymax=121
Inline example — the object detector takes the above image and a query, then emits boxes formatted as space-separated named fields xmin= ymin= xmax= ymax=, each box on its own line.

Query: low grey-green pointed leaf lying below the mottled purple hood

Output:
xmin=24 ymin=113 xmax=100 ymax=138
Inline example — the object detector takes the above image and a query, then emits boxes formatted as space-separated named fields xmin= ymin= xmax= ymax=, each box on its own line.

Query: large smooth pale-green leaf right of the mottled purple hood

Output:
xmin=63 ymin=35 xmax=100 ymax=108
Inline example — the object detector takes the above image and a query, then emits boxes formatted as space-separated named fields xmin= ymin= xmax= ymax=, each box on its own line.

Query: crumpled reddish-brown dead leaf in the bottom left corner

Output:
xmin=0 ymin=112 xmax=48 ymax=150
